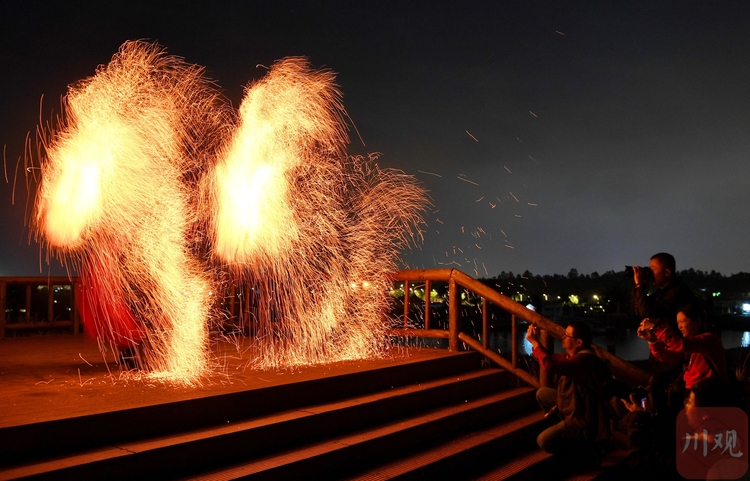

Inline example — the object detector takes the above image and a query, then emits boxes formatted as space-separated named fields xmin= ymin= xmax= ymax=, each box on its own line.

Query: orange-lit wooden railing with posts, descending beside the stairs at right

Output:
xmin=392 ymin=269 xmax=648 ymax=387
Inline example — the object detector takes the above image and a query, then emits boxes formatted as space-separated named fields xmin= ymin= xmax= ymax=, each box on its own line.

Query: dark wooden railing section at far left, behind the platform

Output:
xmin=0 ymin=277 xmax=80 ymax=339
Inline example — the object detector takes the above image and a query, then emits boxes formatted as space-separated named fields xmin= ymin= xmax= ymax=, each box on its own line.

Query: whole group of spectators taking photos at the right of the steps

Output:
xmin=526 ymin=253 xmax=747 ymax=479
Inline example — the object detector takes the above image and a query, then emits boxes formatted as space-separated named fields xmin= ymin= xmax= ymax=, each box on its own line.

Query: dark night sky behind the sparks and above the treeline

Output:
xmin=0 ymin=0 xmax=750 ymax=276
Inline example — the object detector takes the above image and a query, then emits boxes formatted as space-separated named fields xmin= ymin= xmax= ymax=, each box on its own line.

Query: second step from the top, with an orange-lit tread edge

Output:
xmin=0 ymin=360 xmax=524 ymax=479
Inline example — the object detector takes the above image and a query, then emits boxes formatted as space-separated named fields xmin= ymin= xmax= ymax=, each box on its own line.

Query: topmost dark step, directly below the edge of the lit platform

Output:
xmin=0 ymin=352 xmax=482 ymax=467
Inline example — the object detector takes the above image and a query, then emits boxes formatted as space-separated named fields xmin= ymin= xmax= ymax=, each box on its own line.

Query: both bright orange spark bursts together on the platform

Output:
xmin=34 ymin=42 xmax=427 ymax=384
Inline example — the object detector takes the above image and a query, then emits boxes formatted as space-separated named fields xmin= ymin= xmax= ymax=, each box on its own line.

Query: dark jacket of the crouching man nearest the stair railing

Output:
xmin=532 ymin=345 xmax=611 ymax=441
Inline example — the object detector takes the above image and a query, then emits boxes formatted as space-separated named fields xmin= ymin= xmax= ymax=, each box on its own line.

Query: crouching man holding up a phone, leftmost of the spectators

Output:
xmin=526 ymin=321 xmax=611 ymax=453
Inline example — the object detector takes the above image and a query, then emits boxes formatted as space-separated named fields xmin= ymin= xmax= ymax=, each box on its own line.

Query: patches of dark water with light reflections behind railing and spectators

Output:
xmin=489 ymin=324 xmax=750 ymax=361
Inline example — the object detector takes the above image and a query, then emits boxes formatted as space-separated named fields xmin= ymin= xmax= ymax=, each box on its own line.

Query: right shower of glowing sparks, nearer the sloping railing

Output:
xmin=204 ymin=59 xmax=426 ymax=367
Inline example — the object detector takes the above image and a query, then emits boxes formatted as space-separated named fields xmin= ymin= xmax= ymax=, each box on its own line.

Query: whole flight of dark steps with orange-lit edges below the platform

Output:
xmin=0 ymin=351 xmax=636 ymax=480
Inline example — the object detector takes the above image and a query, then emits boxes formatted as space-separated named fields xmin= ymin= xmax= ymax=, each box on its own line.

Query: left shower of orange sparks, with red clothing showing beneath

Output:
xmin=35 ymin=42 xmax=229 ymax=383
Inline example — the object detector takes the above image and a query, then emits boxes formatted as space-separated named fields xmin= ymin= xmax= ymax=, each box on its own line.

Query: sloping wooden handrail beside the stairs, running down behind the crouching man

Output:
xmin=393 ymin=269 xmax=648 ymax=386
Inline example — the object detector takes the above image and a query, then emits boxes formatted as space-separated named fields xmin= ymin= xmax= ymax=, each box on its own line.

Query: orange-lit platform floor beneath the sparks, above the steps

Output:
xmin=0 ymin=334 xmax=449 ymax=427
